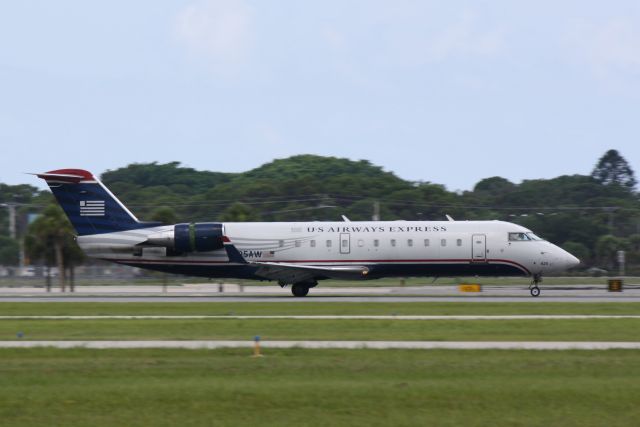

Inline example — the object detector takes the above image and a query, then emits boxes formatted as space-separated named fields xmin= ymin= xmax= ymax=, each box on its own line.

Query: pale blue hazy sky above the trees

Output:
xmin=0 ymin=0 xmax=640 ymax=190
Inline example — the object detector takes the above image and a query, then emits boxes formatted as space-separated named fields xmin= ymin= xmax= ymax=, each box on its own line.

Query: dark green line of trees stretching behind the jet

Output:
xmin=0 ymin=150 xmax=640 ymax=284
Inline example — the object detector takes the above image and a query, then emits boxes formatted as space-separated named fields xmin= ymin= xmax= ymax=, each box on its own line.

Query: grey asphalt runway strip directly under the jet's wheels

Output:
xmin=0 ymin=284 xmax=640 ymax=303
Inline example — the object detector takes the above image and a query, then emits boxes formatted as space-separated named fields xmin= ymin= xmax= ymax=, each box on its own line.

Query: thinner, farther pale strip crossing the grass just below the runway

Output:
xmin=0 ymin=314 xmax=640 ymax=320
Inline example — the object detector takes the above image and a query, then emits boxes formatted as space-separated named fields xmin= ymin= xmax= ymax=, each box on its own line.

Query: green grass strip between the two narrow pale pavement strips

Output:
xmin=0 ymin=319 xmax=640 ymax=341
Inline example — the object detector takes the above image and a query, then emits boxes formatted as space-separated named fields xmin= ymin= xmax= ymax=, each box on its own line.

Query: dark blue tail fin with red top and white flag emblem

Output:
xmin=36 ymin=169 xmax=156 ymax=236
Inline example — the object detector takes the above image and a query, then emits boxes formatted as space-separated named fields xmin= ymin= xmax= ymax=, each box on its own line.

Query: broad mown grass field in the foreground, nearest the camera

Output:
xmin=0 ymin=349 xmax=640 ymax=427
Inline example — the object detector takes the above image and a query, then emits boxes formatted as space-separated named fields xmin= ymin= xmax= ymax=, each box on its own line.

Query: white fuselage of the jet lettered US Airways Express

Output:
xmin=78 ymin=221 xmax=579 ymax=278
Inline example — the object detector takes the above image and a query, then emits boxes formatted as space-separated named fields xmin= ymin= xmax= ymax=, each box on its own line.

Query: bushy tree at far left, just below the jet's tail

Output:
xmin=25 ymin=204 xmax=81 ymax=292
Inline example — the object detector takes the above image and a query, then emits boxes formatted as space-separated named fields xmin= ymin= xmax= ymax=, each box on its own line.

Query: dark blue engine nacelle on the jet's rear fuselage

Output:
xmin=147 ymin=222 xmax=224 ymax=253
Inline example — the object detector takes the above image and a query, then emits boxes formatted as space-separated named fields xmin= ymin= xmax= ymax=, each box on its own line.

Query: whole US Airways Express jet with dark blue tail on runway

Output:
xmin=34 ymin=169 xmax=580 ymax=297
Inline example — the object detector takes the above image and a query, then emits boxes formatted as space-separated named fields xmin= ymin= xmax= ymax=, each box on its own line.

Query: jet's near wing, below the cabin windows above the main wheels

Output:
xmin=248 ymin=262 xmax=369 ymax=283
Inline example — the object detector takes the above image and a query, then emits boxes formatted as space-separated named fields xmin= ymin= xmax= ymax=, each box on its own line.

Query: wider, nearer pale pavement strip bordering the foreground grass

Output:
xmin=0 ymin=341 xmax=640 ymax=350
